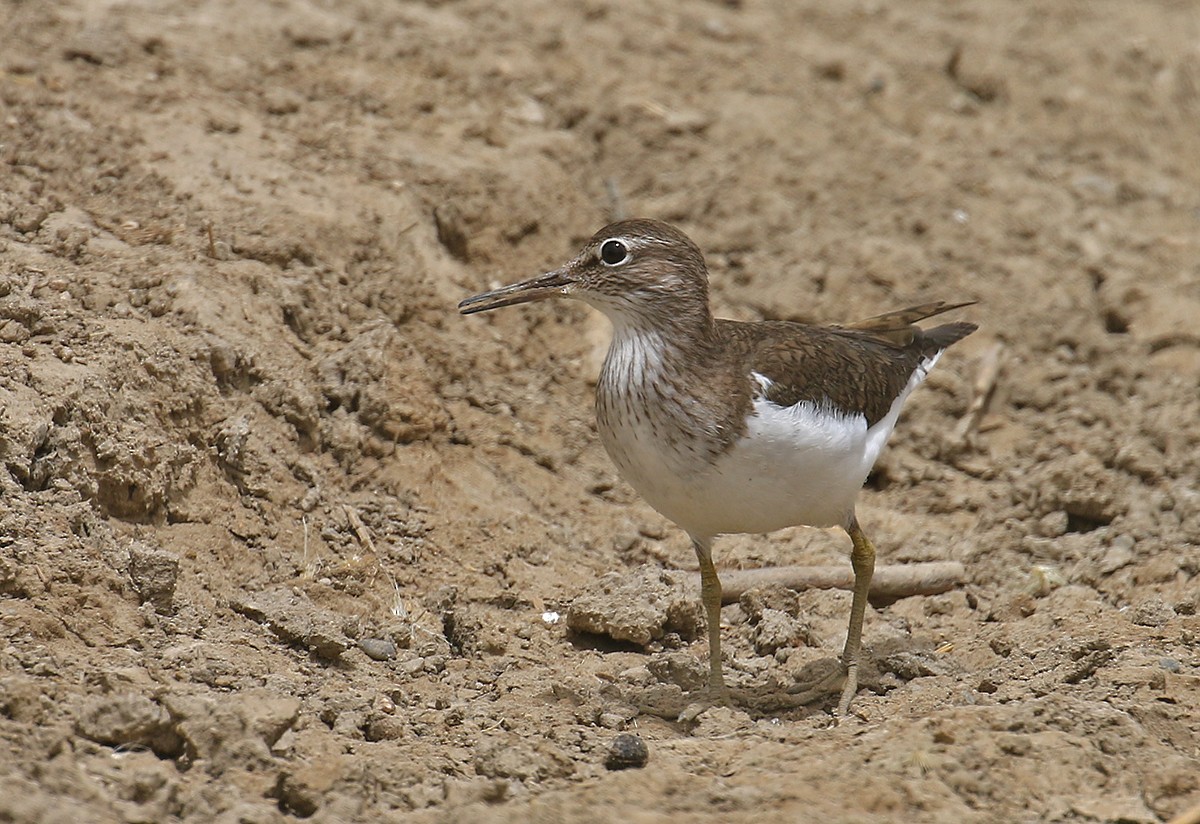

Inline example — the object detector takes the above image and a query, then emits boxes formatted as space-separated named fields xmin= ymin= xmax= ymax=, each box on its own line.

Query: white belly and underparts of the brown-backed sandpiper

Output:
xmin=601 ymin=341 xmax=941 ymax=537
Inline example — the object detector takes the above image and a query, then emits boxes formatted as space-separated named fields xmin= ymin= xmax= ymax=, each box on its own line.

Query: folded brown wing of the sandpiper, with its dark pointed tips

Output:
xmin=718 ymin=303 xmax=976 ymax=426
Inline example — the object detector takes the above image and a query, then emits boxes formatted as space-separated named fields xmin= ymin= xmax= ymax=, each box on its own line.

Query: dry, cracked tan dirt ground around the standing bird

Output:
xmin=0 ymin=0 xmax=1200 ymax=824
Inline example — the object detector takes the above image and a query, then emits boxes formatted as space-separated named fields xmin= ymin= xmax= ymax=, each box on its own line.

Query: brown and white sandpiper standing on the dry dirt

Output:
xmin=458 ymin=219 xmax=976 ymax=715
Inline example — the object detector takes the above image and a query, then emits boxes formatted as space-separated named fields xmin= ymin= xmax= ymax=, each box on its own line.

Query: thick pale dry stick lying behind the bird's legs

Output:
xmin=721 ymin=561 xmax=966 ymax=603
